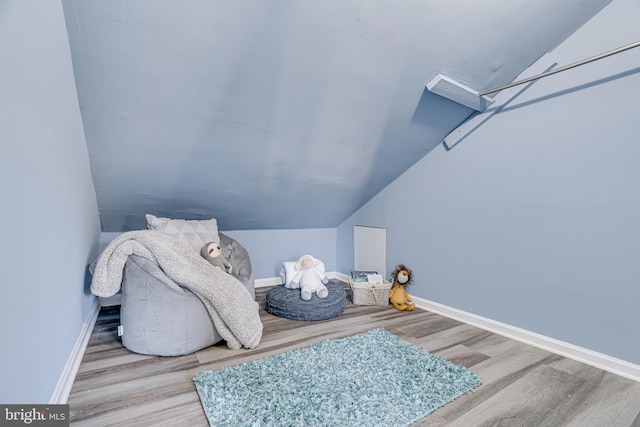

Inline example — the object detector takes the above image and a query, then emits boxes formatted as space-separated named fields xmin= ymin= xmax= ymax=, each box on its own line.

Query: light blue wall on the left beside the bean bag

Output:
xmin=0 ymin=1 xmax=100 ymax=403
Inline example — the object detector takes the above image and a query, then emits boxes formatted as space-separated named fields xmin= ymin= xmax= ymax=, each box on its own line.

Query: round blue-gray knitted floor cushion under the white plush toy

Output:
xmin=265 ymin=280 xmax=347 ymax=320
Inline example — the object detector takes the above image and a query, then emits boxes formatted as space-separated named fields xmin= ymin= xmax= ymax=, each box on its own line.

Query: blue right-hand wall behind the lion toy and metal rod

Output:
xmin=336 ymin=0 xmax=640 ymax=363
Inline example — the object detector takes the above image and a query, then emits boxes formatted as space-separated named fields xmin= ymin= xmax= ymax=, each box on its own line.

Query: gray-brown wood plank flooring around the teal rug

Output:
xmin=68 ymin=288 xmax=640 ymax=427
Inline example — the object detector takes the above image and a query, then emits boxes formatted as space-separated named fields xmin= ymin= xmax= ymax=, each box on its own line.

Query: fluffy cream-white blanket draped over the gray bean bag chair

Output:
xmin=91 ymin=230 xmax=262 ymax=349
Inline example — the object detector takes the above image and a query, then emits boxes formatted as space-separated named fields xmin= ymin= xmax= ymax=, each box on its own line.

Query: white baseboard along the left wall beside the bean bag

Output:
xmin=49 ymin=298 xmax=100 ymax=405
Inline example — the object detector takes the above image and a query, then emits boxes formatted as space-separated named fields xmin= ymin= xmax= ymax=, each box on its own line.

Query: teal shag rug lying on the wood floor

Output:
xmin=193 ymin=329 xmax=482 ymax=427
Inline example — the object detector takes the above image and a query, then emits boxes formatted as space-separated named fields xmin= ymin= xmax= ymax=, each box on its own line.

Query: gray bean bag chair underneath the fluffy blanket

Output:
xmin=120 ymin=233 xmax=255 ymax=356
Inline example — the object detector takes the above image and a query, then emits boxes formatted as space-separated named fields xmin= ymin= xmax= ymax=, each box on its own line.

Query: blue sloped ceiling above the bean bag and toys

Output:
xmin=63 ymin=0 xmax=611 ymax=231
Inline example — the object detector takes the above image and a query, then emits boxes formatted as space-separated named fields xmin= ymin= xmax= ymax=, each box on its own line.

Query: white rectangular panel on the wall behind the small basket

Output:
xmin=353 ymin=225 xmax=387 ymax=278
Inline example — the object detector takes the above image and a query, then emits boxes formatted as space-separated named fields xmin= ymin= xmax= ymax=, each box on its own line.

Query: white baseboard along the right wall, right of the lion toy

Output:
xmin=411 ymin=295 xmax=640 ymax=382
